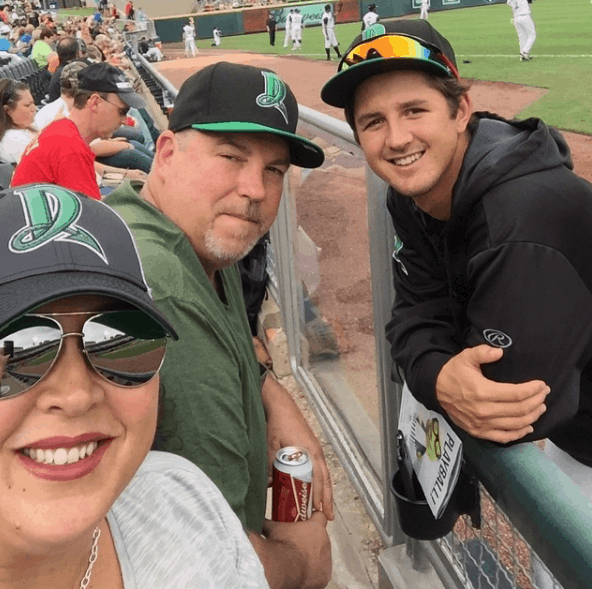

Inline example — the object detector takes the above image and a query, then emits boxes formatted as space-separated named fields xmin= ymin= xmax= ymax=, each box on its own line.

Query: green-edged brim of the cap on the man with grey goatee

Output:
xmin=191 ymin=121 xmax=325 ymax=168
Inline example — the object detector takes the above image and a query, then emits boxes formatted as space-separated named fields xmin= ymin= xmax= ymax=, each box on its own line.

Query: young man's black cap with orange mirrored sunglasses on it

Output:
xmin=321 ymin=20 xmax=460 ymax=108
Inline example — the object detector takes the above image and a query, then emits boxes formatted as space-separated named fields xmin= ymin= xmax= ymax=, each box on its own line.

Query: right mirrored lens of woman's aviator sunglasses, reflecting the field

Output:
xmin=84 ymin=311 xmax=167 ymax=387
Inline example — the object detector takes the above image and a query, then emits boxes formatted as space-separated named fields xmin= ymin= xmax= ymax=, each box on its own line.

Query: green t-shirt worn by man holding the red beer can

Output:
xmin=105 ymin=183 xmax=267 ymax=531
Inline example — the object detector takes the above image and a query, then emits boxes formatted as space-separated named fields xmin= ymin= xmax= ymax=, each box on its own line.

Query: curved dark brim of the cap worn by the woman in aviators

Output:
xmin=0 ymin=271 xmax=179 ymax=340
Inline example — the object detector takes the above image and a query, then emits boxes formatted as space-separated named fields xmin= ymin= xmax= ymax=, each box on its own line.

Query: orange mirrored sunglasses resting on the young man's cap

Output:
xmin=339 ymin=35 xmax=460 ymax=80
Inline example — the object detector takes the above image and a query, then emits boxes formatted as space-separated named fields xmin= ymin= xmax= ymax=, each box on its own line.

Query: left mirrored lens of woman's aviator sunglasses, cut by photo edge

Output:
xmin=0 ymin=317 xmax=61 ymax=399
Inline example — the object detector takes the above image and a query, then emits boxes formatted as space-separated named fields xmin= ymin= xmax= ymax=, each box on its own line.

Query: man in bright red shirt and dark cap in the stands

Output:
xmin=11 ymin=63 xmax=145 ymax=200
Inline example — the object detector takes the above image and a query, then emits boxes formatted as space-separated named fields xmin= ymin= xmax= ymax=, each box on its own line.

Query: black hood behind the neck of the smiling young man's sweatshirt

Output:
xmin=450 ymin=112 xmax=573 ymax=225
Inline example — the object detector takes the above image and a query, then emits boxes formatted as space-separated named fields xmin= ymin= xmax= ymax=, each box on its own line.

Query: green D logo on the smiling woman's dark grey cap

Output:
xmin=8 ymin=184 xmax=109 ymax=264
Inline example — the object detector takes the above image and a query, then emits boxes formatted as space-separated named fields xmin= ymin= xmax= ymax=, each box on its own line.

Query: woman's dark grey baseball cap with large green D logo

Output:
xmin=0 ymin=184 xmax=177 ymax=339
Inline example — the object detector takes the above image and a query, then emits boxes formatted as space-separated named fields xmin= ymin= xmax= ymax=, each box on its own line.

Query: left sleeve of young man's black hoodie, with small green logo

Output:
xmin=386 ymin=191 xmax=463 ymax=411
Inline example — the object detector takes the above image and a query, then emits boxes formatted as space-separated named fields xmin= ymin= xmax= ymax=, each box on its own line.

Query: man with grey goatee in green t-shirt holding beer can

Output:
xmin=106 ymin=62 xmax=333 ymax=589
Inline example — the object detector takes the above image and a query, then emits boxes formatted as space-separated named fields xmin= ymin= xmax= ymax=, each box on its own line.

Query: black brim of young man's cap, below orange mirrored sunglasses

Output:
xmin=321 ymin=57 xmax=450 ymax=108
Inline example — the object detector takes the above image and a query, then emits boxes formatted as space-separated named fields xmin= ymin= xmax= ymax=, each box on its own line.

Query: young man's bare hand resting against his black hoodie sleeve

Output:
xmin=436 ymin=345 xmax=551 ymax=444
